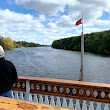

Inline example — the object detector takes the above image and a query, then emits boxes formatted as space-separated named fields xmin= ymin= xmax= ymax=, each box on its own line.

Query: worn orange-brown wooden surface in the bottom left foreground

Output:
xmin=0 ymin=97 xmax=73 ymax=110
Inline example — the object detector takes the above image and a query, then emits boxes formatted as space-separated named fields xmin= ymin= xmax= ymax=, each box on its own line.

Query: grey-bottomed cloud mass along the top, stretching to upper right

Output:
xmin=16 ymin=0 xmax=110 ymax=27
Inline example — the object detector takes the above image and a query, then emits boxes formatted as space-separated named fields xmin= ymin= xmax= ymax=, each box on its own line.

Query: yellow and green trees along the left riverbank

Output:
xmin=0 ymin=36 xmax=41 ymax=50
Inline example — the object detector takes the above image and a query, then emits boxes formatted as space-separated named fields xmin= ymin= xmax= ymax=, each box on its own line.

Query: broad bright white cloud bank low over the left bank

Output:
xmin=0 ymin=9 xmax=68 ymax=44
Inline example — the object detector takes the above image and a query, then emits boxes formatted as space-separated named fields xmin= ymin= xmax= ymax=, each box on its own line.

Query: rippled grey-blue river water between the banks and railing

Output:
xmin=5 ymin=47 xmax=110 ymax=83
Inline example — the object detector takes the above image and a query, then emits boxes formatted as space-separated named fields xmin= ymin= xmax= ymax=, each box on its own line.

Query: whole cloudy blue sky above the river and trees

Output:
xmin=0 ymin=0 xmax=110 ymax=45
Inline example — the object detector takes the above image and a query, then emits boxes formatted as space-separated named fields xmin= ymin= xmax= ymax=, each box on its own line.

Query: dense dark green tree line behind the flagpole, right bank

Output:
xmin=52 ymin=30 xmax=110 ymax=56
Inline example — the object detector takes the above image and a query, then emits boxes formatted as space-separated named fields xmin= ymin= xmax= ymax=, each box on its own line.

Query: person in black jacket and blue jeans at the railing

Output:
xmin=0 ymin=45 xmax=18 ymax=98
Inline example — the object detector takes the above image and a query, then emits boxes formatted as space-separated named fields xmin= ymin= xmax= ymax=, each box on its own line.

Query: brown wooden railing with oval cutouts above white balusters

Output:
xmin=13 ymin=76 xmax=110 ymax=110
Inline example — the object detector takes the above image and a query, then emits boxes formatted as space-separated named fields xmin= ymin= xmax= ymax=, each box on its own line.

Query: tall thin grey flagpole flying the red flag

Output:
xmin=80 ymin=13 xmax=84 ymax=81
